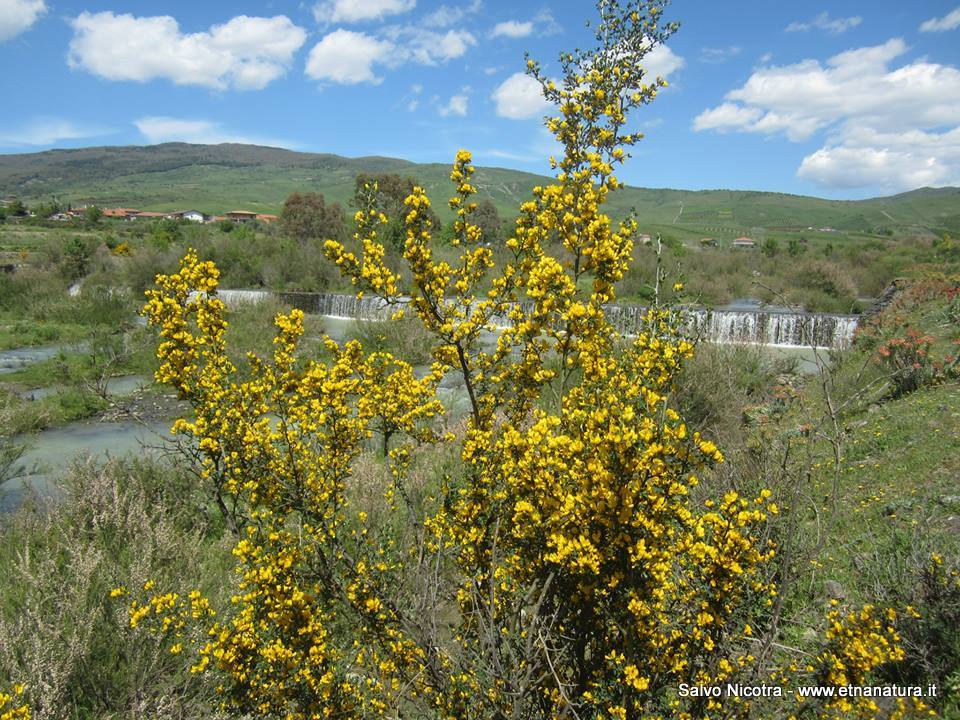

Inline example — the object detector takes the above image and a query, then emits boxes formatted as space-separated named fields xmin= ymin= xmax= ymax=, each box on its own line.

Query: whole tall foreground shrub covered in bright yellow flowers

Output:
xmin=124 ymin=1 xmax=912 ymax=718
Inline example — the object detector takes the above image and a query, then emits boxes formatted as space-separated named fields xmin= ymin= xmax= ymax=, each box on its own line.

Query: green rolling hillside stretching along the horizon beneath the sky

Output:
xmin=0 ymin=143 xmax=960 ymax=238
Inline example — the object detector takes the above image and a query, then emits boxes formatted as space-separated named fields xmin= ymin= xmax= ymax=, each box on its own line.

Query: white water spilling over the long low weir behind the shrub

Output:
xmin=219 ymin=290 xmax=859 ymax=349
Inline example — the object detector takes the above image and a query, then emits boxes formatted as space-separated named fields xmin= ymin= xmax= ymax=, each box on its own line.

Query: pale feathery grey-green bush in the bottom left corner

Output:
xmin=0 ymin=461 xmax=229 ymax=720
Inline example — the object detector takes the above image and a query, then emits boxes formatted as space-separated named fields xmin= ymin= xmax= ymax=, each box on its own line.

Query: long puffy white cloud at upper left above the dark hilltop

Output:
xmin=68 ymin=12 xmax=307 ymax=90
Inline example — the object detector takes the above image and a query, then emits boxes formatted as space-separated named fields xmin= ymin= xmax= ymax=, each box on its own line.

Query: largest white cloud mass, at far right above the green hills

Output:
xmin=693 ymin=38 xmax=960 ymax=189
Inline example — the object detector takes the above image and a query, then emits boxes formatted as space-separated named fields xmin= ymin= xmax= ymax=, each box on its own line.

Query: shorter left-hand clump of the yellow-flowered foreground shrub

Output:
xmin=136 ymin=246 xmax=444 ymax=717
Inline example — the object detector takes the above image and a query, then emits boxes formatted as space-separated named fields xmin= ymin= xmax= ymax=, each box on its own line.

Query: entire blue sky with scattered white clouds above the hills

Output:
xmin=0 ymin=0 xmax=960 ymax=198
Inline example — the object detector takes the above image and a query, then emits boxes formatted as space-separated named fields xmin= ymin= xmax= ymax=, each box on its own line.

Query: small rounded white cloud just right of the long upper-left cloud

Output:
xmin=306 ymin=29 xmax=395 ymax=85
